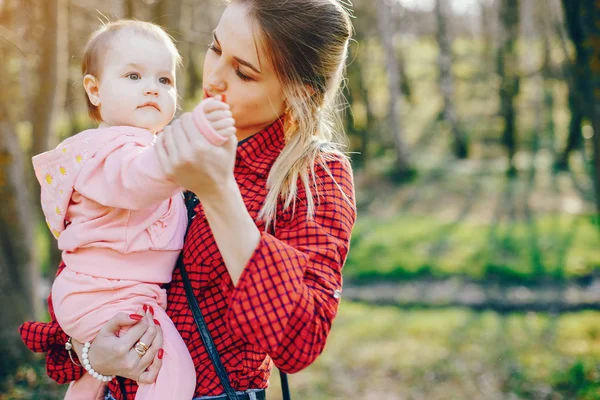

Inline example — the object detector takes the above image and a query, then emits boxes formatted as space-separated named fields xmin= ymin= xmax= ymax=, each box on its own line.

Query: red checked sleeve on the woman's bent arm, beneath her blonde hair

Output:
xmin=226 ymin=161 xmax=356 ymax=373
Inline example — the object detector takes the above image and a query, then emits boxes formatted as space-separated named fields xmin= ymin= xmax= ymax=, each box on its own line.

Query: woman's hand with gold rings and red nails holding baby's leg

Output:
xmin=72 ymin=312 xmax=163 ymax=384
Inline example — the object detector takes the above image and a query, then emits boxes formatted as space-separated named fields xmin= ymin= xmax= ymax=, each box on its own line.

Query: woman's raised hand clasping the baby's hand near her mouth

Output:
xmin=156 ymin=100 xmax=237 ymax=200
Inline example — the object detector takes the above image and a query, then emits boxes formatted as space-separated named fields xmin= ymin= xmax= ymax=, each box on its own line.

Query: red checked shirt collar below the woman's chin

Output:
xmin=237 ymin=119 xmax=285 ymax=176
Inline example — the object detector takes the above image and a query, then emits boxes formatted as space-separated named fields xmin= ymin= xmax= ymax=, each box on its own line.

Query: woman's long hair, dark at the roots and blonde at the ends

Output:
xmin=233 ymin=0 xmax=354 ymax=228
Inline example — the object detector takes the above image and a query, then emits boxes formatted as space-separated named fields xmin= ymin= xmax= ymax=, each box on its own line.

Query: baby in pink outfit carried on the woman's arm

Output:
xmin=33 ymin=21 xmax=235 ymax=400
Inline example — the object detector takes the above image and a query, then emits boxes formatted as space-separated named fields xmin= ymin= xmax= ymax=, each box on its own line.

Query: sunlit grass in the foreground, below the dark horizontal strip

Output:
xmin=268 ymin=302 xmax=600 ymax=400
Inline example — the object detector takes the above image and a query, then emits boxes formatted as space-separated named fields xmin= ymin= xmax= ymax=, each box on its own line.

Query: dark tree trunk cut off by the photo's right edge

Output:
xmin=579 ymin=0 xmax=600 ymax=213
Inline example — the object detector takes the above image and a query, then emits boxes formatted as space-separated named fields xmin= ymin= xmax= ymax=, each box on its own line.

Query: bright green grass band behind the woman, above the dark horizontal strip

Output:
xmin=344 ymin=214 xmax=600 ymax=282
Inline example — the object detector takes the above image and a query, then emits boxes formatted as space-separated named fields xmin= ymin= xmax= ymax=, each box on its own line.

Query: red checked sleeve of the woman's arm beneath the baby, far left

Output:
xmin=19 ymin=263 xmax=85 ymax=384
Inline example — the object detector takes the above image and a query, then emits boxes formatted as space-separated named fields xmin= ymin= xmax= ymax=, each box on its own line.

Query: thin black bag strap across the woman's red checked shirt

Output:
xmin=177 ymin=192 xmax=291 ymax=400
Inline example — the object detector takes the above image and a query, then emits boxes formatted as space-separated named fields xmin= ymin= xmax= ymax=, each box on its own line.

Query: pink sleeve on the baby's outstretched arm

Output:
xmin=73 ymin=135 xmax=182 ymax=210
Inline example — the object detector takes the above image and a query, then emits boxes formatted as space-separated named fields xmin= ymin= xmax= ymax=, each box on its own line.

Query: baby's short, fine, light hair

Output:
xmin=81 ymin=19 xmax=181 ymax=122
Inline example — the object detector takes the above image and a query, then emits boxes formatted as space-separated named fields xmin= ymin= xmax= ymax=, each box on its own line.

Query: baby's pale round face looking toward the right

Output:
xmin=91 ymin=31 xmax=177 ymax=133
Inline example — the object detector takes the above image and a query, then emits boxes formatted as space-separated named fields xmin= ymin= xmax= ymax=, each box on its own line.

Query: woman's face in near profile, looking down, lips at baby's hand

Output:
xmin=202 ymin=3 xmax=285 ymax=140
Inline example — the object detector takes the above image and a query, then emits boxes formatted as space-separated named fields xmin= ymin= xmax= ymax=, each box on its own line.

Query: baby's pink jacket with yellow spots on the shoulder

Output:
xmin=33 ymin=126 xmax=187 ymax=283
